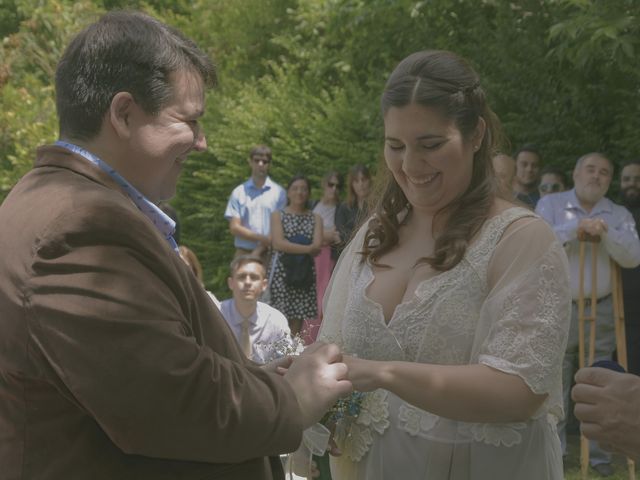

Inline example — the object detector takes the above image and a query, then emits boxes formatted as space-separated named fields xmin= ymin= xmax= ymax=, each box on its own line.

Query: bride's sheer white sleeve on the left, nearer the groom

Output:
xmin=318 ymin=222 xmax=368 ymax=348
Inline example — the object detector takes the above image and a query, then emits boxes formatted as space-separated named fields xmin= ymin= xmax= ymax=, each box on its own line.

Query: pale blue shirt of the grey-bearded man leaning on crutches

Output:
xmin=536 ymin=189 xmax=640 ymax=300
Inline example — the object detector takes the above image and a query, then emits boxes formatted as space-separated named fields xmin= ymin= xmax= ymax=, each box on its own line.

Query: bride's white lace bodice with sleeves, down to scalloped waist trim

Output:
xmin=320 ymin=208 xmax=570 ymax=476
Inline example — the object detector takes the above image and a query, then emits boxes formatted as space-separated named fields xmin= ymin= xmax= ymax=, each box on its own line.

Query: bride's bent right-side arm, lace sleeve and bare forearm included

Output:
xmin=345 ymin=219 xmax=570 ymax=423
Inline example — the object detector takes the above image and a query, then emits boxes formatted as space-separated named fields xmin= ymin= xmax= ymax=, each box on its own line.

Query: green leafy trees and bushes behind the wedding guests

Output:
xmin=0 ymin=0 xmax=640 ymax=298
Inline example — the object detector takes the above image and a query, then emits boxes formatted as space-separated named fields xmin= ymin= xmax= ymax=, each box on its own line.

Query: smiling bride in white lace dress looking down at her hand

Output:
xmin=319 ymin=51 xmax=570 ymax=480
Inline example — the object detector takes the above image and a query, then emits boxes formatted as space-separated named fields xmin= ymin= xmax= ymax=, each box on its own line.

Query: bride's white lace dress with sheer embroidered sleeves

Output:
xmin=319 ymin=208 xmax=571 ymax=480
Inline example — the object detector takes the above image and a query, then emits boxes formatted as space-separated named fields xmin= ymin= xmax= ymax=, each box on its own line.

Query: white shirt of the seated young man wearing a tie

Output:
xmin=220 ymin=298 xmax=291 ymax=363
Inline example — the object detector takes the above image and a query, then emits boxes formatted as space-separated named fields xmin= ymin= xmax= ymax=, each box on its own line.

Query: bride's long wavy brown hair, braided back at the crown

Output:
xmin=362 ymin=50 xmax=500 ymax=271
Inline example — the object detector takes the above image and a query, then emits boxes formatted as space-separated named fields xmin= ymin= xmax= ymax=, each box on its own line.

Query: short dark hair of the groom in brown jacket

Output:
xmin=56 ymin=11 xmax=217 ymax=140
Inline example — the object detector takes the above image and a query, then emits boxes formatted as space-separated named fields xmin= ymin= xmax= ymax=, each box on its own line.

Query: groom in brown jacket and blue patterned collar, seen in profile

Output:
xmin=0 ymin=12 xmax=351 ymax=480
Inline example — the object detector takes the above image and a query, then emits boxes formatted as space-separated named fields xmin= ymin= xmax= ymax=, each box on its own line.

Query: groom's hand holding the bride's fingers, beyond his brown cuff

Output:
xmin=284 ymin=342 xmax=353 ymax=428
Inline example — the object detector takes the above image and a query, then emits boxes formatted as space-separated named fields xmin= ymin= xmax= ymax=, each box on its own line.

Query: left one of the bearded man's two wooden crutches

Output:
xmin=578 ymin=232 xmax=600 ymax=479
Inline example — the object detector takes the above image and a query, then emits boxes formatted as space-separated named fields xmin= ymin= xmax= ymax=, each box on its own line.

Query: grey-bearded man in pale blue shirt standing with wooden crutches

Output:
xmin=536 ymin=153 xmax=640 ymax=476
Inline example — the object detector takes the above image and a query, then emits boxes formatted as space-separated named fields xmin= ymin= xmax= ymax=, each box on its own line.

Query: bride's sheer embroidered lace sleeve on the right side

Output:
xmin=474 ymin=218 xmax=571 ymax=409
